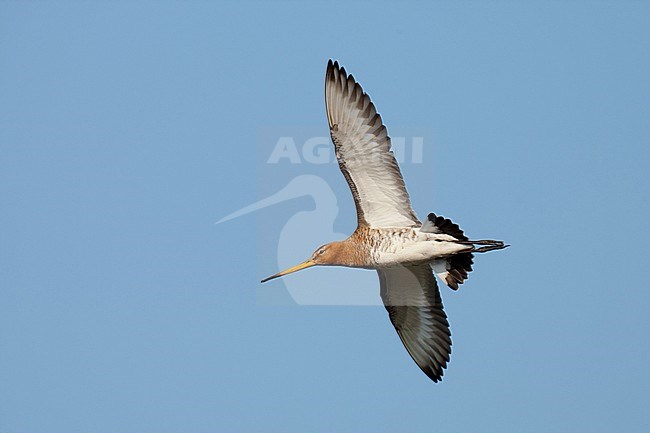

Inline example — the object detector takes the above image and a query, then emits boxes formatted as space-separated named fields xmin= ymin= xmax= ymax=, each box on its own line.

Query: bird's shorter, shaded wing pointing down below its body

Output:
xmin=377 ymin=264 xmax=451 ymax=382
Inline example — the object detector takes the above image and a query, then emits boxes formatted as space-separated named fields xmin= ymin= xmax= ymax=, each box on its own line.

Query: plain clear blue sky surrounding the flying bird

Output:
xmin=0 ymin=1 xmax=650 ymax=433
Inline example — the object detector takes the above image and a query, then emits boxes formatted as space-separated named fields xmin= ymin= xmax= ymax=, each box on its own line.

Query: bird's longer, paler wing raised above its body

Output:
xmin=325 ymin=60 xmax=420 ymax=227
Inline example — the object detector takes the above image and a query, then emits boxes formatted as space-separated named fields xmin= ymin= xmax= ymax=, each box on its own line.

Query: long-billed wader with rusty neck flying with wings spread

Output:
xmin=262 ymin=60 xmax=508 ymax=382
